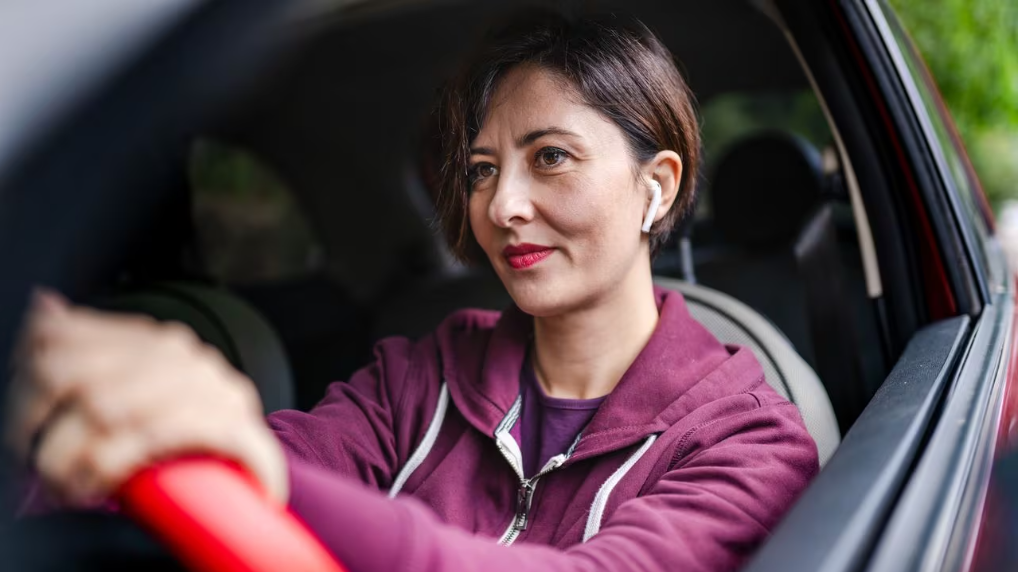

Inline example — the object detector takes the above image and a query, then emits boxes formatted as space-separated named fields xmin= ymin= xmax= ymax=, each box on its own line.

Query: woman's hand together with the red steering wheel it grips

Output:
xmin=6 ymin=292 xmax=342 ymax=572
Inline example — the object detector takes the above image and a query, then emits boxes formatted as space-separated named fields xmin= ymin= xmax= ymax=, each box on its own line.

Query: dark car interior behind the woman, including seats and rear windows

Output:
xmin=89 ymin=2 xmax=901 ymax=469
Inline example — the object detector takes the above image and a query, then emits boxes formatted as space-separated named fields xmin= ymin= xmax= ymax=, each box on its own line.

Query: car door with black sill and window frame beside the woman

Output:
xmin=747 ymin=1 xmax=1017 ymax=571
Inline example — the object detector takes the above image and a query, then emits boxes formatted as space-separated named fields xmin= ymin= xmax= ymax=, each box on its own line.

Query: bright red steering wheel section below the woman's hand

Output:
xmin=118 ymin=458 xmax=345 ymax=572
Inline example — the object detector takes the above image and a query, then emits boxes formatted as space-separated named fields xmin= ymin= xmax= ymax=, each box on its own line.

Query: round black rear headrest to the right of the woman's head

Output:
xmin=710 ymin=133 xmax=823 ymax=249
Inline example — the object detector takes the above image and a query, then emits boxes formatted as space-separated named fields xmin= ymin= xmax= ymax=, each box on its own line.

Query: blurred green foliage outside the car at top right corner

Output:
xmin=889 ymin=0 xmax=1017 ymax=211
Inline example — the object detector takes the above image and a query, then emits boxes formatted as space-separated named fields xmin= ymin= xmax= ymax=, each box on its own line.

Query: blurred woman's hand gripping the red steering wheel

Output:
xmin=7 ymin=292 xmax=288 ymax=505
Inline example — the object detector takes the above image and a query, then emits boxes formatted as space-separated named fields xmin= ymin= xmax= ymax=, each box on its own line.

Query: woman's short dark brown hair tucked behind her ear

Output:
xmin=437 ymin=12 xmax=701 ymax=260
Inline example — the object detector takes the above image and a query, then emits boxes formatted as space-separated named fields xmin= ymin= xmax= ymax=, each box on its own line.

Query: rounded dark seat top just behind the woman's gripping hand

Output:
xmin=100 ymin=282 xmax=294 ymax=413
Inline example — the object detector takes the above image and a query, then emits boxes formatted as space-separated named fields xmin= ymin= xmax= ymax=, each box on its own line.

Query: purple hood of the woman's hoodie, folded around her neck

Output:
xmin=437 ymin=287 xmax=764 ymax=461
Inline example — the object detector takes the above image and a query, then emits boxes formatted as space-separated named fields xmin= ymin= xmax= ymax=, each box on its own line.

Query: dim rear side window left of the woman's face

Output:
xmin=189 ymin=140 xmax=323 ymax=284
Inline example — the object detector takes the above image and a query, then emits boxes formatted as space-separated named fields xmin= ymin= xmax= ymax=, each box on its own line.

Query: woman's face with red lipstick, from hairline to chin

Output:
xmin=468 ymin=67 xmax=651 ymax=316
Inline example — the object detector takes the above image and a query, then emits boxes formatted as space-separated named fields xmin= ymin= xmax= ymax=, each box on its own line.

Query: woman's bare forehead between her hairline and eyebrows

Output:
xmin=475 ymin=65 xmax=616 ymax=146
